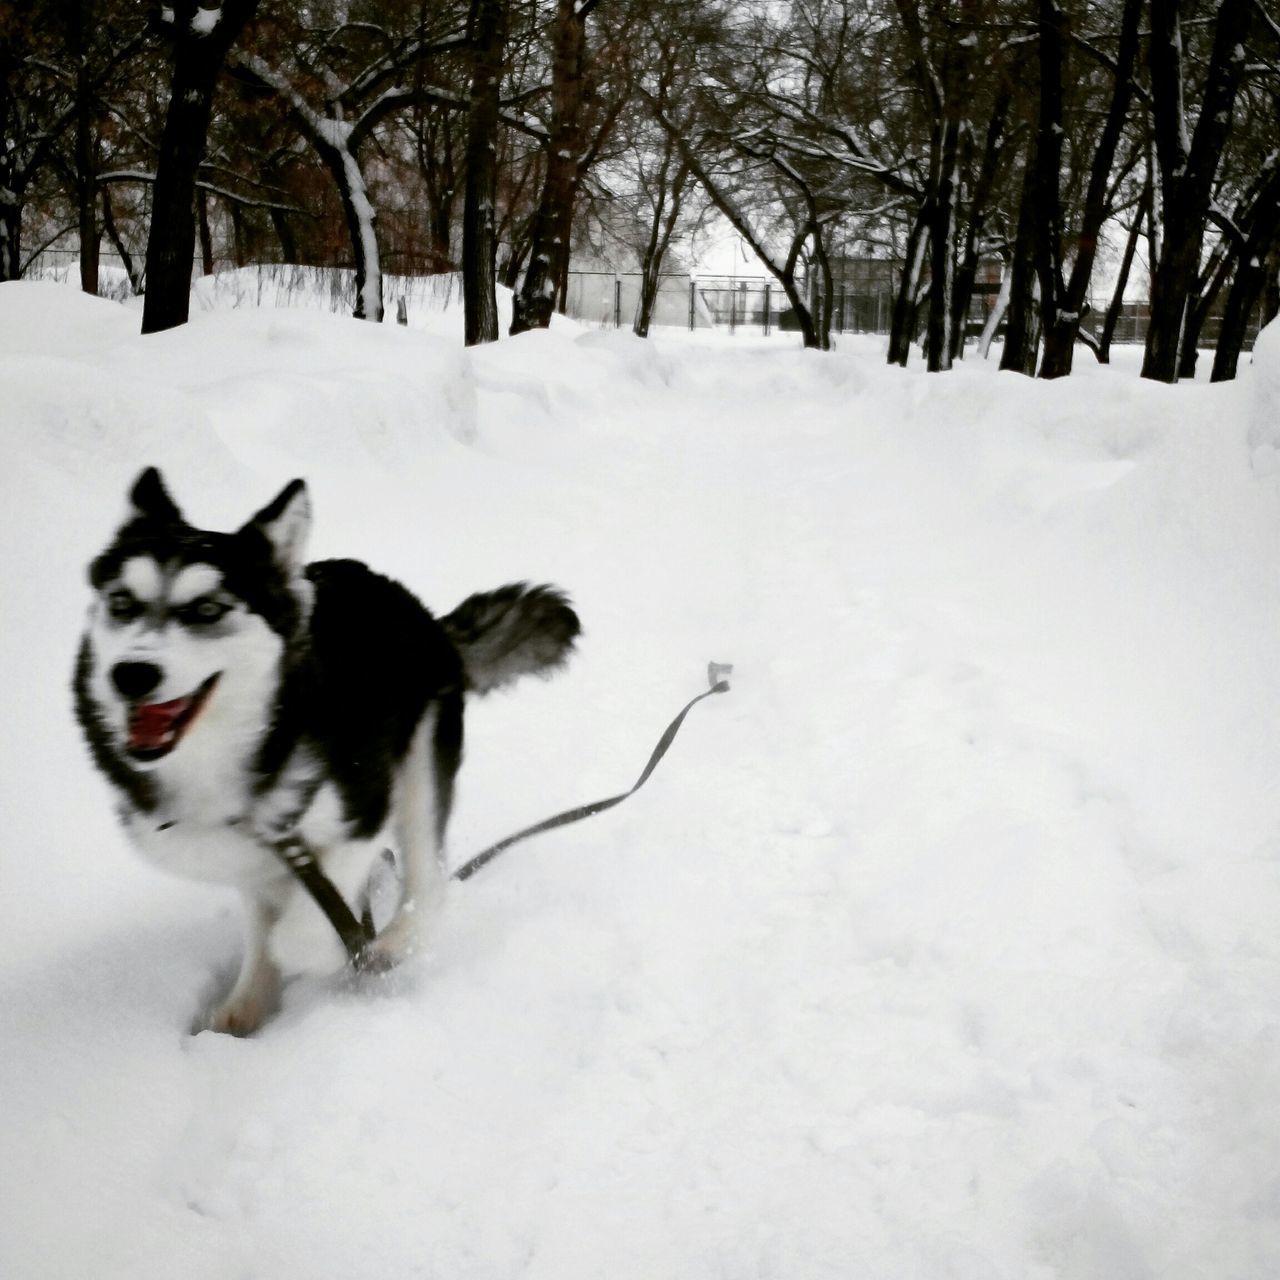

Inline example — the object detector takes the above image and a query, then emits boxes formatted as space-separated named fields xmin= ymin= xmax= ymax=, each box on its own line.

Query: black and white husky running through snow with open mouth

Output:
xmin=74 ymin=467 xmax=579 ymax=1034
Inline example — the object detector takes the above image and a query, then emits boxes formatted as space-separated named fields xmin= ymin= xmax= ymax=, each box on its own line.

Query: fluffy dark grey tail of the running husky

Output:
xmin=440 ymin=582 xmax=582 ymax=694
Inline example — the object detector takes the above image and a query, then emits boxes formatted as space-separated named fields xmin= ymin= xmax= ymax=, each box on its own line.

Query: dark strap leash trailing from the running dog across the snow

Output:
xmin=271 ymin=662 xmax=733 ymax=970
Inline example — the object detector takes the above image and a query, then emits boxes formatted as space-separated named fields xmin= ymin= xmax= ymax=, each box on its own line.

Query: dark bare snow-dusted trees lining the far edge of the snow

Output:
xmin=0 ymin=0 xmax=1280 ymax=381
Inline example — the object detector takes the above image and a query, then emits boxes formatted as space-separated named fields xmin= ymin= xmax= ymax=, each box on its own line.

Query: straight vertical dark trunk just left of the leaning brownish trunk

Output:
xmin=462 ymin=0 xmax=507 ymax=347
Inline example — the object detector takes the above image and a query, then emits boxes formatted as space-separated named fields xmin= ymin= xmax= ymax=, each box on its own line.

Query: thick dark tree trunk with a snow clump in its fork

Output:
xmin=142 ymin=0 xmax=257 ymax=333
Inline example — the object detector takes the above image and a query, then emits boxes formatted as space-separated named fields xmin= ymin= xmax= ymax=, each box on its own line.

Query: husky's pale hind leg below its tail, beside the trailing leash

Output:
xmin=369 ymin=692 xmax=462 ymax=968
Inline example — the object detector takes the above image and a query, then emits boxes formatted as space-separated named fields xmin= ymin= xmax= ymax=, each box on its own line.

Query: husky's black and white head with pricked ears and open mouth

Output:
xmin=82 ymin=467 xmax=311 ymax=765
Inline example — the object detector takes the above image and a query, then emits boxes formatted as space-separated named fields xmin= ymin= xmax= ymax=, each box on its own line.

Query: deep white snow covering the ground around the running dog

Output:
xmin=0 ymin=284 xmax=1280 ymax=1280
